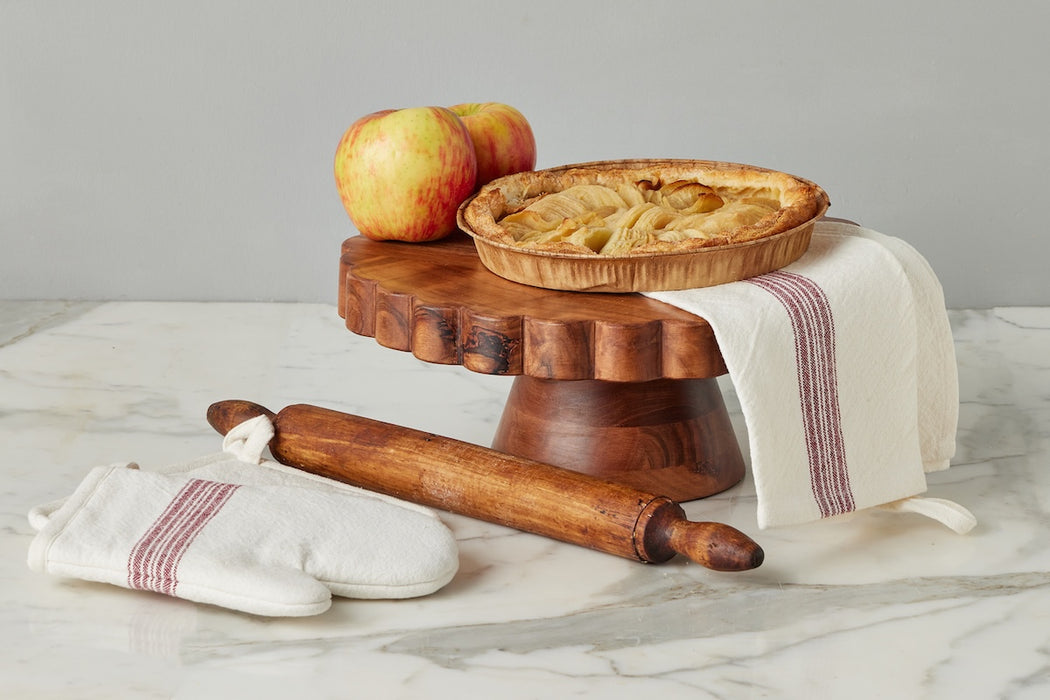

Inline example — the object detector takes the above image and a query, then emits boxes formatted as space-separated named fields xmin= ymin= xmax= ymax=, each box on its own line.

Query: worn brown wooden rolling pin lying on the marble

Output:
xmin=208 ymin=401 xmax=763 ymax=571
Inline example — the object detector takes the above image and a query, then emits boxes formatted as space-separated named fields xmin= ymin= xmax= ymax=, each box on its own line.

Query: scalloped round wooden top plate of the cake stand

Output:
xmin=338 ymin=233 xmax=726 ymax=382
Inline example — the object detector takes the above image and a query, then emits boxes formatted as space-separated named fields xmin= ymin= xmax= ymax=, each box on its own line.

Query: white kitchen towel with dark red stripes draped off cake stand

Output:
xmin=647 ymin=221 xmax=975 ymax=532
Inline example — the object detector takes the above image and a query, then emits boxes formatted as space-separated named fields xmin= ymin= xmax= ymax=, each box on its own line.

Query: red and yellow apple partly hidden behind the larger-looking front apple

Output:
xmin=449 ymin=102 xmax=536 ymax=189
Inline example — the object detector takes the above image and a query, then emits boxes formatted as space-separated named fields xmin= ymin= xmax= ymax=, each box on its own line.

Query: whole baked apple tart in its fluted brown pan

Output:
xmin=459 ymin=160 xmax=828 ymax=291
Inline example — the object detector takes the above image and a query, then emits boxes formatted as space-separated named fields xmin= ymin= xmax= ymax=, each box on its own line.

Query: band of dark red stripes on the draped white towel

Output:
xmin=748 ymin=271 xmax=854 ymax=517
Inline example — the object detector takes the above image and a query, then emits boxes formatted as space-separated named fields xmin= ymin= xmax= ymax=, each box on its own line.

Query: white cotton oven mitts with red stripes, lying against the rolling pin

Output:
xmin=28 ymin=416 xmax=459 ymax=616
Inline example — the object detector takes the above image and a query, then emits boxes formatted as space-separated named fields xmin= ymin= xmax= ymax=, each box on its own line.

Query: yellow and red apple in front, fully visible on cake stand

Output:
xmin=335 ymin=107 xmax=478 ymax=241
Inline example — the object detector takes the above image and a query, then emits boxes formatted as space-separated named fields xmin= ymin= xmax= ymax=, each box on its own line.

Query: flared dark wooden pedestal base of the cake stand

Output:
xmin=492 ymin=377 xmax=744 ymax=501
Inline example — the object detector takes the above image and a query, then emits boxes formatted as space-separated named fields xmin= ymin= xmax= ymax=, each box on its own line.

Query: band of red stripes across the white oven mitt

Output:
xmin=128 ymin=479 xmax=237 ymax=596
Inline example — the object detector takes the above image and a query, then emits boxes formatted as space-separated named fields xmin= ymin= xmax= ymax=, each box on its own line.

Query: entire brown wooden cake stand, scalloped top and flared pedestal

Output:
xmin=339 ymin=233 xmax=744 ymax=501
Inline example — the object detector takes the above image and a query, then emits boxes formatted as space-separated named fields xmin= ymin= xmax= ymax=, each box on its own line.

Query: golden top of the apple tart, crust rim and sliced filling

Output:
xmin=461 ymin=160 xmax=828 ymax=257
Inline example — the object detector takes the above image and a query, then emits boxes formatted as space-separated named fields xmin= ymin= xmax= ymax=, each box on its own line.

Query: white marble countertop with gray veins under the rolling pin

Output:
xmin=0 ymin=301 xmax=1050 ymax=699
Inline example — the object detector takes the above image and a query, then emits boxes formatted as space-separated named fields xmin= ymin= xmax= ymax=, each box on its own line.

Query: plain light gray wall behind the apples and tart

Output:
xmin=0 ymin=0 xmax=1050 ymax=307
